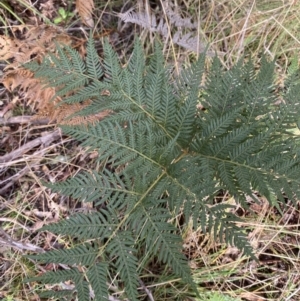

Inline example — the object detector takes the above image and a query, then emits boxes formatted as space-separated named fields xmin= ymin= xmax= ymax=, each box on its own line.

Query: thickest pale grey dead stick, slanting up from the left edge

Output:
xmin=0 ymin=129 xmax=61 ymax=167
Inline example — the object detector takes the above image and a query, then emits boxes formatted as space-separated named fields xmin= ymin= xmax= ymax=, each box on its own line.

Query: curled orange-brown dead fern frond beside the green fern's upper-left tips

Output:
xmin=0 ymin=26 xmax=110 ymax=125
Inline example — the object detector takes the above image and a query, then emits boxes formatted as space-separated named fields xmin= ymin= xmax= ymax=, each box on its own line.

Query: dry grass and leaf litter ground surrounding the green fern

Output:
xmin=0 ymin=0 xmax=300 ymax=301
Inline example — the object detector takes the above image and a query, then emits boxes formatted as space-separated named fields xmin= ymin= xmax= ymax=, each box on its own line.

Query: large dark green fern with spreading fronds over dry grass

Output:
xmin=26 ymin=39 xmax=300 ymax=301
